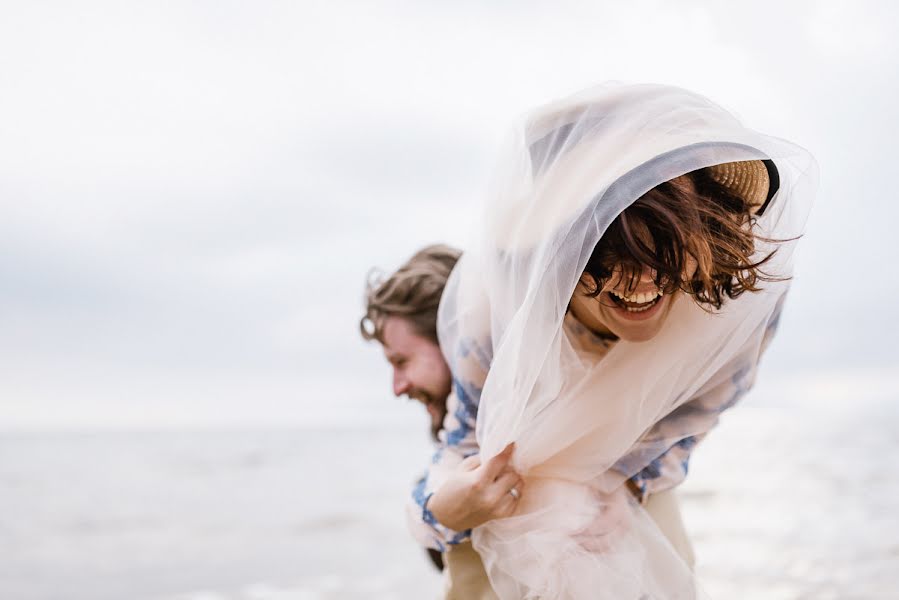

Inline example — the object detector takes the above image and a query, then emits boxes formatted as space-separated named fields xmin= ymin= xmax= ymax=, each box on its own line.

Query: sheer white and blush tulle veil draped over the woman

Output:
xmin=438 ymin=84 xmax=816 ymax=600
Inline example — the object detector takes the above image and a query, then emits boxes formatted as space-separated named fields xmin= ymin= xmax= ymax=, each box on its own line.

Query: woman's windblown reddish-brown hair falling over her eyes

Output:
xmin=584 ymin=169 xmax=787 ymax=309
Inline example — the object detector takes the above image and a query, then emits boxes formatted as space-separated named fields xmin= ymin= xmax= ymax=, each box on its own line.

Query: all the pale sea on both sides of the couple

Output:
xmin=0 ymin=392 xmax=899 ymax=600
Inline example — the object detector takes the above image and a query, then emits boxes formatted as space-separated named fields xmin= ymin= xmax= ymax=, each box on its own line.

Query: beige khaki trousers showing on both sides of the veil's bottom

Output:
xmin=443 ymin=490 xmax=696 ymax=600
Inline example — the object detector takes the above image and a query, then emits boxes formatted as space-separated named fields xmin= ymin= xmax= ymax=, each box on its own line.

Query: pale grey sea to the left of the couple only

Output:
xmin=0 ymin=430 xmax=440 ymax=600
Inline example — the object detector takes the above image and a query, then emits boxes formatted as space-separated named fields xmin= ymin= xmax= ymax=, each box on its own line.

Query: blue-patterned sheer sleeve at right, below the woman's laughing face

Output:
xmin=613 ymin=297 xmax=784 ymax=501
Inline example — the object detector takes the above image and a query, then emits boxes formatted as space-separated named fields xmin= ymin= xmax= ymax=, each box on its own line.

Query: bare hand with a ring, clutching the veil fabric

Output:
xmin=428 ymin=442 xmax=524 ymax=531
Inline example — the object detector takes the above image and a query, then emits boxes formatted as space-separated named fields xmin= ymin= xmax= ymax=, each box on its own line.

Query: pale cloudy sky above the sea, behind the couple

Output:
xmin=0 ymin=0 xmax=899 ymax=430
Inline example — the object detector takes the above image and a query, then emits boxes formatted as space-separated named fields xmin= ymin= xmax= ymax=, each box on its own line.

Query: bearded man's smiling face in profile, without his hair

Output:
xmin=381 ymin=316 xmax=452 ymax=434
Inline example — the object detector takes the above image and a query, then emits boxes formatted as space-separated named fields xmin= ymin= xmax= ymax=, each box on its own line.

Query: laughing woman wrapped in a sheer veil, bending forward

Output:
xmin=426 ymin=84 xmax=815 ymax=600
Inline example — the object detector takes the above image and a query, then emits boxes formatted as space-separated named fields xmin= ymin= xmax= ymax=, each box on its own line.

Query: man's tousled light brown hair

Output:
xmin=359 ymin=244 xmax=462 ymax=344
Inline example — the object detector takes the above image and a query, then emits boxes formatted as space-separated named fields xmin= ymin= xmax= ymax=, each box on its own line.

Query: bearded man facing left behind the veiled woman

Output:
xmin=360 ymin=245 xmax=518 ymax=600
